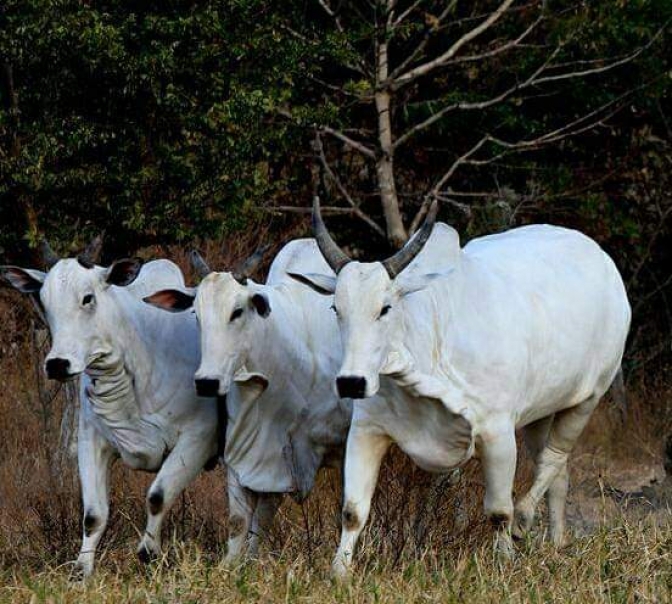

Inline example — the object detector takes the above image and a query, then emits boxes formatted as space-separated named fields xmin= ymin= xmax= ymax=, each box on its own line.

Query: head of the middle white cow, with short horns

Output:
xmin=145 ymin=245 xmax=271 ymax=396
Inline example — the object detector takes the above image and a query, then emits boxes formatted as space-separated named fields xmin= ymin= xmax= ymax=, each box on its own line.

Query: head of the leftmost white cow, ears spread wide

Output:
xmin=0 ymin=251 xmax=142 ymax=381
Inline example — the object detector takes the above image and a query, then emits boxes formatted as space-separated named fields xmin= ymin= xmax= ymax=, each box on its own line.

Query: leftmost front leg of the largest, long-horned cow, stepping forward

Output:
xmin=332 ymin=424 xmax=392 ymax=578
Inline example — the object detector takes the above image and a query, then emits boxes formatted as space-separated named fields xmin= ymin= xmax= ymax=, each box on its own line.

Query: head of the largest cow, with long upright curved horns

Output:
xmin=290 ymin=198 xmax=438 ymax=398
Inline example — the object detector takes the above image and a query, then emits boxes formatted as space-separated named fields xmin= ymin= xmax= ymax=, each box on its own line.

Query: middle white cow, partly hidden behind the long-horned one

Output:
xmin=146 ymin=240 xmax=352 ymax=562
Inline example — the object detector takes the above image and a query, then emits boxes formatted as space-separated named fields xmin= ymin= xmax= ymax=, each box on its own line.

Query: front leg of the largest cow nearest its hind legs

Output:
xmin=480 ymin=425 xmax=517 ymax=557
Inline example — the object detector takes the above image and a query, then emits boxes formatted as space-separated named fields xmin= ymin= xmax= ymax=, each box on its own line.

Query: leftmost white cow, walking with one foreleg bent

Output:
xmin=0 ymin=258 xmax=217 ymax=576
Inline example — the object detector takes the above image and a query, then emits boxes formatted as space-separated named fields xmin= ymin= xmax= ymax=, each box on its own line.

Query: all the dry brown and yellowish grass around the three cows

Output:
xmin=0 ymin=232 xmax=672 ymax=602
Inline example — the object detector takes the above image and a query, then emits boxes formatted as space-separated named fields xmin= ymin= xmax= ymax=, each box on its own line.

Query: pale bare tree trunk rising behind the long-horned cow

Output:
xmin=375 ymin=22 xmax=408 ymax=248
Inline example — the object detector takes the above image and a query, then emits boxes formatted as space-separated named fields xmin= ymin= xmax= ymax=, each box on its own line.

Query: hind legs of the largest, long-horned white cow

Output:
xmin=516 ymin=396 xmax=600 ymax=545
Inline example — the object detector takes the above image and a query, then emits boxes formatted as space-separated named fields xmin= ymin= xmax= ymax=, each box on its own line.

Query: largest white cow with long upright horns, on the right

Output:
xmin=294 ymin=201 xmax=630 ymax=575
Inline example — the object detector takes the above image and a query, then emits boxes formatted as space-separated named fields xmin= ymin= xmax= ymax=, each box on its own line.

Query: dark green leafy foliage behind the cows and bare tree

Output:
xmin=0 ymin=0 xmax=672 ymax=372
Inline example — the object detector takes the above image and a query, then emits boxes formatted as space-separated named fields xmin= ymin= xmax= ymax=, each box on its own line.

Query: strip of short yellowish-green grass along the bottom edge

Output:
xmin=0 ymin=518 xmax=672 ymax=604
